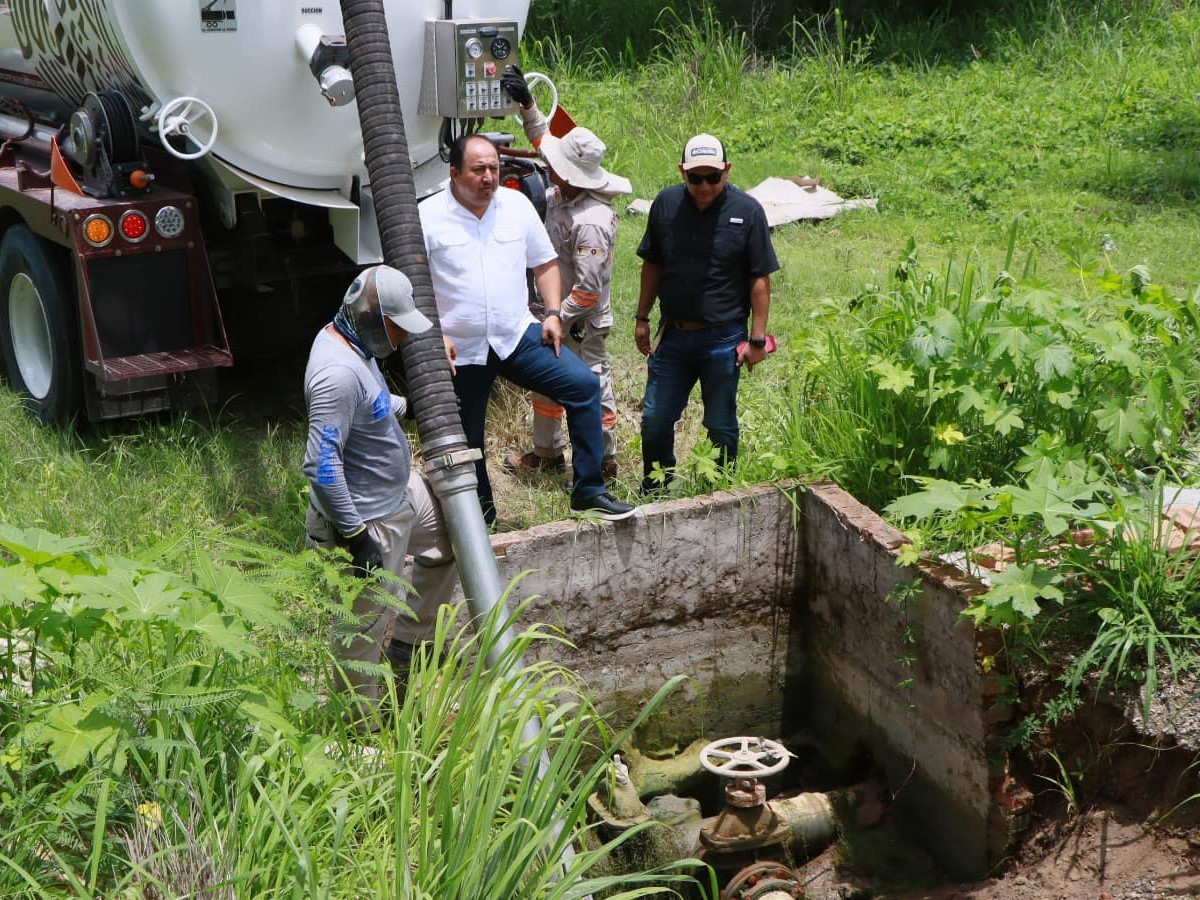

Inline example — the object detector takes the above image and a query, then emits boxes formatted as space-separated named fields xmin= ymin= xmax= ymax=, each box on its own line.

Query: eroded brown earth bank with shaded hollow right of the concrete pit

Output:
xmin=787 ymin=672 xmax=1200 ymax=900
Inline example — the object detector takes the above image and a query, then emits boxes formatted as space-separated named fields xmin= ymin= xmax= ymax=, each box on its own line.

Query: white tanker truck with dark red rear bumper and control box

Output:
xmin=0 ymin=0 xmax=528 ymax=422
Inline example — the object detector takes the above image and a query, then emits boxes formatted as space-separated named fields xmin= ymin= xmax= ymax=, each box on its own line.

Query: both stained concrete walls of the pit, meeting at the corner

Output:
xmin=463 ymin=485 xmax=1012 ymax=878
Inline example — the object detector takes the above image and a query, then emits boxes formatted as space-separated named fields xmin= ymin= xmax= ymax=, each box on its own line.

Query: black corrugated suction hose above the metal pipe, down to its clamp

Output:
xmin=342 ymin=0 xmax=467 ymax=458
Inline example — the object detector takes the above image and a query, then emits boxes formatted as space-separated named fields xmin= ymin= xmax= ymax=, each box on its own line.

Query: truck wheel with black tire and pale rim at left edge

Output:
xmin=0 ymin=226 xmax=82 ymax=425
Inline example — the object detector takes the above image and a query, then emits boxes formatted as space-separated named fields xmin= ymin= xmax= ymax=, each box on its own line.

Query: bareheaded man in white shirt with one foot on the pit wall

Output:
xmin=420 ymin=134 xmax=634 ymax=524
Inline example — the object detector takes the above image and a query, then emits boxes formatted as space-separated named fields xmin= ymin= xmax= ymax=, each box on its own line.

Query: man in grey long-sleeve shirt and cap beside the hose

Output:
xmin=304 ymin=265 xmax=455 ymax=721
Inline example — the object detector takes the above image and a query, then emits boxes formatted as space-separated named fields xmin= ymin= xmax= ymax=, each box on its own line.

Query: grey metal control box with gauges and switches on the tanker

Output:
xmin=418 ymin=19 xmax=521 ymax=119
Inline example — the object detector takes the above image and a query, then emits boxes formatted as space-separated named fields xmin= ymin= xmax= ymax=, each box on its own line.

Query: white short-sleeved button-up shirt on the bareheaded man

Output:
xmin=420 ymin=187 xmax=558 ymax=366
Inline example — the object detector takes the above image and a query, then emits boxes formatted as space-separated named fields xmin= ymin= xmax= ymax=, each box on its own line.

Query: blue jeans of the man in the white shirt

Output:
xmin=454 ymin=325 xmax=606 ymax=524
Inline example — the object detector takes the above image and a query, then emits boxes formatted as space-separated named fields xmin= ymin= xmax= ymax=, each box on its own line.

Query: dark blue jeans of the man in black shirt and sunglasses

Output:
xmin=642 ymin=322 xmax=746 ymax=490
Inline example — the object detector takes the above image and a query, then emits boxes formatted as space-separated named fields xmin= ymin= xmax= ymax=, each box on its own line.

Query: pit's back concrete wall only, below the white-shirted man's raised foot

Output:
xmin=492 ymin=488 xmax=798 ymax=748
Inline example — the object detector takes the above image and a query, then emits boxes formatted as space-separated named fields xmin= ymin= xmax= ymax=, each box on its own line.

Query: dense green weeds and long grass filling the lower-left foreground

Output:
xmin=0 ymin=528 xmax=712 ymax=900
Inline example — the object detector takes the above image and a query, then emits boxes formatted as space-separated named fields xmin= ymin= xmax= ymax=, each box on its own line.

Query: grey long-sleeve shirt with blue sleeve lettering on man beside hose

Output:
xmin=304 ymin=329 xmax=412 ymax=535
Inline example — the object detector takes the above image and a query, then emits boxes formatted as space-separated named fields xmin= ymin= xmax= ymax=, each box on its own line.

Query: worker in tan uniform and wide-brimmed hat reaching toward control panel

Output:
xmin=500 ymin=67 xmax=632 ymax=479
